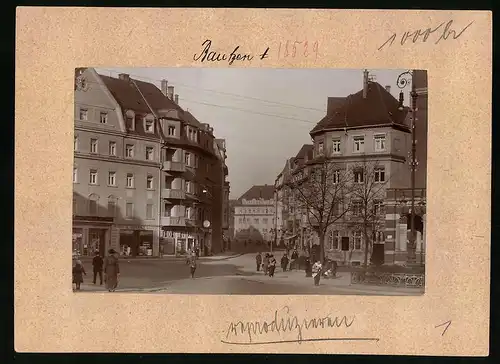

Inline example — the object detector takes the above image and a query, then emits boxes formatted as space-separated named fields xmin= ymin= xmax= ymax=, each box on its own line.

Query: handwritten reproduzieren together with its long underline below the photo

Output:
xmin=221 ymin=306 xmax=379 ymax=345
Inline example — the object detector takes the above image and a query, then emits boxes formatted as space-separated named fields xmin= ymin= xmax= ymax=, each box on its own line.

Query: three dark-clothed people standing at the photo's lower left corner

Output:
xmin=73 ymin=249 xmax=120 ymax=292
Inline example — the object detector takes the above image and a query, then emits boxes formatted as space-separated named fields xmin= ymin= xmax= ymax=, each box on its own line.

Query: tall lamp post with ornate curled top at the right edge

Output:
xmin=397 ymin=71 xmax=418 ymax=263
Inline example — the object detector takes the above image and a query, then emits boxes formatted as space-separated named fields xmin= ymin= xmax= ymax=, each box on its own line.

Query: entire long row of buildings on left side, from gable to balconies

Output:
xmin=73 ymin=69 xmax=227 ymax=255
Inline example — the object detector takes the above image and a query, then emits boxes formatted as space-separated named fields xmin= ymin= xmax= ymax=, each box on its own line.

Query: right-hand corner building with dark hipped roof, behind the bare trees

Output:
xmin=302 ymin=71 xmax=411 ymax=265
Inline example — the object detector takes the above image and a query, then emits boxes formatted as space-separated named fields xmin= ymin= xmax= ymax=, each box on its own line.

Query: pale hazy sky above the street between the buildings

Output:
xmin=96 ymin=68 xmax=409 ymax=199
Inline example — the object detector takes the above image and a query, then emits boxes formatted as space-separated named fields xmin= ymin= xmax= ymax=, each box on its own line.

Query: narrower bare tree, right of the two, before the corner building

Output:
xmin=349 ymin=158 xmax=392 ymax=267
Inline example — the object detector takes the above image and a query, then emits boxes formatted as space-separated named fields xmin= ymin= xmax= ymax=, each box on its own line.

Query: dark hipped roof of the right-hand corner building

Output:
xmin=310 ymin=82 xmax=406 ymax=135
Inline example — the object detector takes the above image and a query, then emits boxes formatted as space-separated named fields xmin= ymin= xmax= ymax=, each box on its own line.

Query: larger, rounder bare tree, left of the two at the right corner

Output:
xmin=292 ymin=157 xmax=352 ymax=261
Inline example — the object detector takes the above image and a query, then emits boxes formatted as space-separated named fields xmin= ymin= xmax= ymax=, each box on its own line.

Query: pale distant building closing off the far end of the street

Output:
xmin=234 ymin=185 xmax=278 ymax=245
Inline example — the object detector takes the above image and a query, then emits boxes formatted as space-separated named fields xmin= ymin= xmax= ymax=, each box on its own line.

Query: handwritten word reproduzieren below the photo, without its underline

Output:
xmin=226 ymin=306 xmax=355 ymax=343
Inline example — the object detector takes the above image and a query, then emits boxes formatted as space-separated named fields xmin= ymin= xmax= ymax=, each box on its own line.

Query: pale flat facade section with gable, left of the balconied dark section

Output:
xmin=73 ymin=68 xmax=160 ymax=255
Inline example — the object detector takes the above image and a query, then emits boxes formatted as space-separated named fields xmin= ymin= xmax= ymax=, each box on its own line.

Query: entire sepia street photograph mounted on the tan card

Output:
xmin=72 ymin=67 xmax=428 ymax=296
